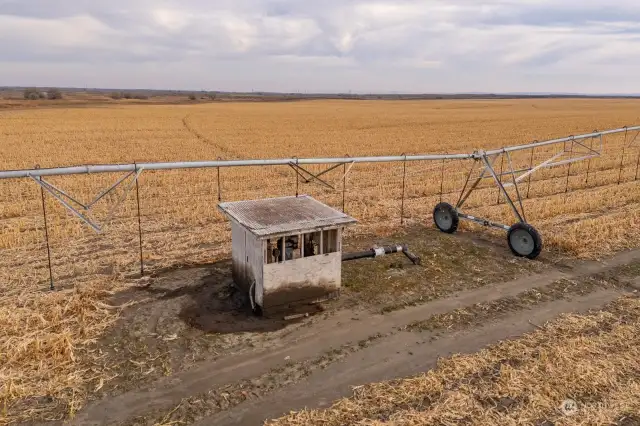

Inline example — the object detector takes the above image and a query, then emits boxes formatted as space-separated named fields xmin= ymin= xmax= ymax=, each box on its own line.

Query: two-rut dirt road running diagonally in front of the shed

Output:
xmin=66 ymin=243 xmax=640 ymax=425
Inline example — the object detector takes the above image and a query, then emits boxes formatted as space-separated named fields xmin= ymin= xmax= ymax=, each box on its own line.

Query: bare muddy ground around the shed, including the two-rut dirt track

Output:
xmin=40 ymin=227 xmax=640 ymax=425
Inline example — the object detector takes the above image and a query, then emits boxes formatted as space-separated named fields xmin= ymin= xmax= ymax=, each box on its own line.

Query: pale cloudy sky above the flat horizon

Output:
xmin=0 ymin=0 xmax=640 ymax=93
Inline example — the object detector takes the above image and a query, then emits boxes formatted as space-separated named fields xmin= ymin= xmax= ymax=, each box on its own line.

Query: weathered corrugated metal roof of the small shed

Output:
xmin=218 ymin=195 xmax=357 ymax=237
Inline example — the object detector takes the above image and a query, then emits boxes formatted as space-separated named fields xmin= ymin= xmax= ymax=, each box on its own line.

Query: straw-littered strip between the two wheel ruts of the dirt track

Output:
xmin=131 ymin=268 xmax=630 ymax=426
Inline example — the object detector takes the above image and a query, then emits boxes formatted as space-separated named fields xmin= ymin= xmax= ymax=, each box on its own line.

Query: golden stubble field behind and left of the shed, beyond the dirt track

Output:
xmin=0 ymin=100 xmax=640 ymax=423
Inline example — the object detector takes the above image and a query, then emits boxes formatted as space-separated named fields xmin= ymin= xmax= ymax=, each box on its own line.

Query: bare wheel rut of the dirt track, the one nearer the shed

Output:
xmin=67 ymin=250 xmax=640 ymax=425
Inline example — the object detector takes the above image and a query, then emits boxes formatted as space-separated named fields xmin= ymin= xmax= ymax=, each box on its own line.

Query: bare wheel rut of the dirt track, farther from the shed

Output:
xmin=208 ymin=290 xmax=622 ymax=426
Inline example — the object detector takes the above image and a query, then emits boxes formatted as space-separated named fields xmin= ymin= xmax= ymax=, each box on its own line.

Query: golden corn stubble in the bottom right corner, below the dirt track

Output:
xmin=266 ymin=298 xmax=640 ymax=426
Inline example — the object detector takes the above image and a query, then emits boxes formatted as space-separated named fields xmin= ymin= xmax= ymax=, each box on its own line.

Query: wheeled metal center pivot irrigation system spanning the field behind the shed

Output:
xmin=0 ymin=126 xmax=640 ymax=272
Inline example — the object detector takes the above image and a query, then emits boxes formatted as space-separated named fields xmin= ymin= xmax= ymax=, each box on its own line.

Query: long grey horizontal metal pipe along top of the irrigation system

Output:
xmin=0 ymin=126 xmax=640 ymax=179
